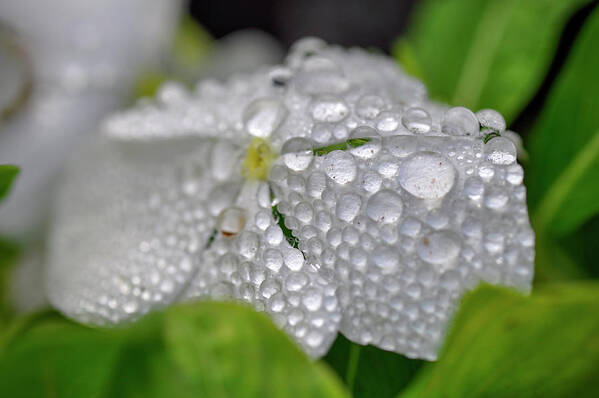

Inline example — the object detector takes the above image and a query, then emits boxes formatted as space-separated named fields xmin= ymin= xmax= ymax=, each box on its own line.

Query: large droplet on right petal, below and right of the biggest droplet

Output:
xmin=418 ymin=230 xmax=461 ymax=268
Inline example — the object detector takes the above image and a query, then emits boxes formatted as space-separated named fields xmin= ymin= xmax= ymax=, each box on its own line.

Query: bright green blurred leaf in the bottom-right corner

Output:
xmin=401 ymin=282 xmax=599 ymax=398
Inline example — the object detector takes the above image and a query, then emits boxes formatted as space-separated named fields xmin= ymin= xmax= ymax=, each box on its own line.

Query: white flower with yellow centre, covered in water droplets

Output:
xmin=47 ymin=39 xmax=534 ymax=359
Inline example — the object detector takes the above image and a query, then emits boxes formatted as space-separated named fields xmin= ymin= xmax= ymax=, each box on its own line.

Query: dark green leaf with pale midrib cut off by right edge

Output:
xmin=527 ymin=8 xmax=599 ymax=236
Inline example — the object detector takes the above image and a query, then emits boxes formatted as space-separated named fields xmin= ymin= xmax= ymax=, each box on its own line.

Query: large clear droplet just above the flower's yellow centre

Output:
xmin=243 ymin=98 xmax=288 ymax=138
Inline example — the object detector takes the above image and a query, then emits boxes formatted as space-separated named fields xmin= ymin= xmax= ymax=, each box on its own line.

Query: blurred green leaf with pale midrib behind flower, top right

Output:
xmin=394 ymin=0 xmax=589 ymax=124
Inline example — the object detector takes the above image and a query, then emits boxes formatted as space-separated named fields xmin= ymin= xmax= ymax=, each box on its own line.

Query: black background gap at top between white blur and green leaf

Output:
xmin=190 ymin=0 xmax=415 ymax=51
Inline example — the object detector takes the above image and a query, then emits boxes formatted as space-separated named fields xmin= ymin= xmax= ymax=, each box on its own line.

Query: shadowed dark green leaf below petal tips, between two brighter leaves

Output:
xmin=324 ymin=334 xmax=423 ymax=398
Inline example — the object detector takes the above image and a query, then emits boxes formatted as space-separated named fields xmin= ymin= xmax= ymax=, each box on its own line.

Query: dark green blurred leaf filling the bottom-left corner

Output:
xmin=0 ymin=319 xmax=119 ymax=398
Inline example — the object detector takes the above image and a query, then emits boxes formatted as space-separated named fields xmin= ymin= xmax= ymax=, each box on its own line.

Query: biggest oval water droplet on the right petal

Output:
xmin=398 ymin=152 xmax=456 ymax=199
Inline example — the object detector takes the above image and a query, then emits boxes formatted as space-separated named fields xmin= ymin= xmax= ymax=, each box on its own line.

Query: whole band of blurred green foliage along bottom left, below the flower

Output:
xmin=0 ymin=303 xmax=347 ymax=398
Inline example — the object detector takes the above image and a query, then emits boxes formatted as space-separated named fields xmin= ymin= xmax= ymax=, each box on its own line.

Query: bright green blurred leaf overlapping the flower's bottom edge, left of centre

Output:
xmin=165 ymin=303 xmax=347 ymax=398
